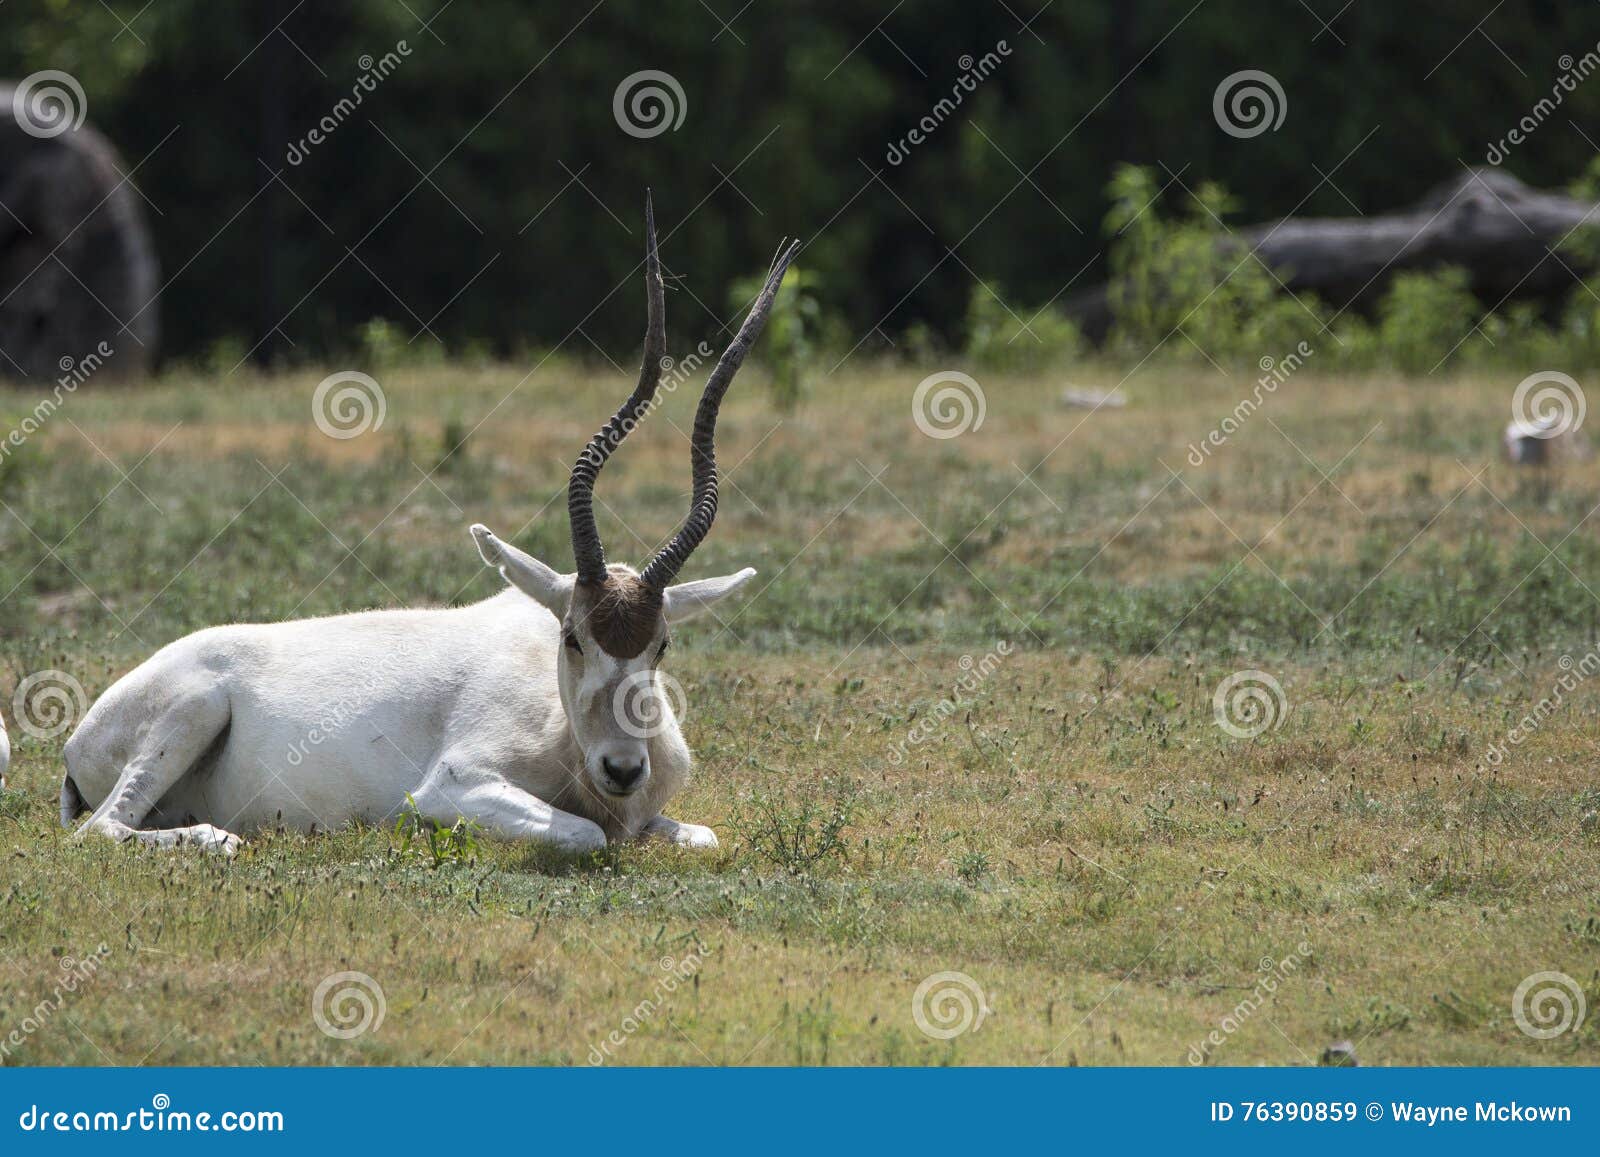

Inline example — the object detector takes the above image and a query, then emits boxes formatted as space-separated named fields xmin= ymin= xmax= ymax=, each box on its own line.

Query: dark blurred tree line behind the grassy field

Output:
xmin=0 ymin=0 xmax=1600 ymax=360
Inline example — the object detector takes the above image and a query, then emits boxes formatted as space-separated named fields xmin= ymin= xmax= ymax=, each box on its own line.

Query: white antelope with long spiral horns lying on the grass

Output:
xmin=61 ymin=200 xmax=800 ymax=855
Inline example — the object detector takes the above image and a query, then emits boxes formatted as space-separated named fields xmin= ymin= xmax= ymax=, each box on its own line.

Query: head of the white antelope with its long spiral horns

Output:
xmin=472 ymin=197 xmax=800 ymax=799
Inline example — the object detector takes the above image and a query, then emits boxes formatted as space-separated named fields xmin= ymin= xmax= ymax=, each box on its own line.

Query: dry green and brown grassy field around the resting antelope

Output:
xmin=0 ymin=362 xmax=1600 ymax=1064
